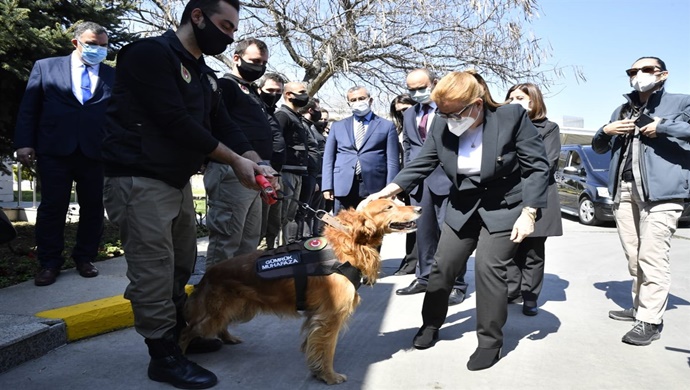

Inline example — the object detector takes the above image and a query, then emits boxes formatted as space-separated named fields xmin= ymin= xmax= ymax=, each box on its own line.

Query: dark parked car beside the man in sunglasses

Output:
xmin=554 ymin=145 xmax=614 ymax=225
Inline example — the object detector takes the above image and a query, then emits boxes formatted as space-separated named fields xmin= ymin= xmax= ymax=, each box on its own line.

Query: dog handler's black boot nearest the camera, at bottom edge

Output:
xmin=148 ymin=355 xmax=218 ymax=389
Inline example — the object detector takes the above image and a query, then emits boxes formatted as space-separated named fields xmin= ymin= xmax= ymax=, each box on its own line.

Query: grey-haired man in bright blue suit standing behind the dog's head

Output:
xmin=321 ymin=86 xmax=400 ymax=214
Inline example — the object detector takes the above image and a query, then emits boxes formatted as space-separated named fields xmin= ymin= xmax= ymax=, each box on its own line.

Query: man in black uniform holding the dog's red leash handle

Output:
xmin=103 ymin=0 xmax=275 ymax=389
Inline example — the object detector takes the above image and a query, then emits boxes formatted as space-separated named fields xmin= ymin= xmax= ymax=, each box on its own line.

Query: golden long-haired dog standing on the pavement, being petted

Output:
xmin=180 ymin=199 xmax=421 ymax=385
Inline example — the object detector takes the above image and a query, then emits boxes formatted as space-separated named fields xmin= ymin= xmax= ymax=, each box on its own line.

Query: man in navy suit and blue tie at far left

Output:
xmin=14 ymin=22 xmax=115 ymax=286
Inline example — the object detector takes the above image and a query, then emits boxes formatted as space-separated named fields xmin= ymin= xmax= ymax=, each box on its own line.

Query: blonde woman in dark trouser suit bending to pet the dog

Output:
xmin=363 ymin=71 xmax=549 ymax=371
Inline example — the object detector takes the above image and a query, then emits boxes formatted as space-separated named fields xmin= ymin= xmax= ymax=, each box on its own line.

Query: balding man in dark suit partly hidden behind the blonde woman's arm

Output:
xmin=395 ymin=69 xmax=467 ymax=305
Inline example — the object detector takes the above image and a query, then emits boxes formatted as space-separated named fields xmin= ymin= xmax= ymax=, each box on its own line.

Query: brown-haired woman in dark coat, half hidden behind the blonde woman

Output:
xmin=506 ymin=83 xmax=563 ymax=316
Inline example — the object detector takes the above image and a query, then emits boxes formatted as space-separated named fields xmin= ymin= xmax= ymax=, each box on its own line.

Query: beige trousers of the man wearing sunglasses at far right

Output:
xmin=613 ymin=182 xmax=683 ymax=324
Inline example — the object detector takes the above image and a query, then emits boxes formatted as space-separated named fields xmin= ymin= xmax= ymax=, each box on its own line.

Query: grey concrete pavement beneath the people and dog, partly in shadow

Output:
xmin=0 ymin=219 xmax=690 ymax=390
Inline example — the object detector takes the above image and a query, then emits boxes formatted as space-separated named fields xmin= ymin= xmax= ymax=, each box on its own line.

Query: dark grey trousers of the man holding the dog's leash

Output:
xmin=103 ymin=177 xmax=196 ymax=339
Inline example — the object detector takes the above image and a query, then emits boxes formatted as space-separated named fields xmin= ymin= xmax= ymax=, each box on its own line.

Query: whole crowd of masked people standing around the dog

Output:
xmin=15 ymin=0 xmax=690 ymax=388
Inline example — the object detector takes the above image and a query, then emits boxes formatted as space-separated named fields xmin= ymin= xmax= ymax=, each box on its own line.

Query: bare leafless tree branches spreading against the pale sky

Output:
xmin=125 ymin=0 xmax=584 ymax=102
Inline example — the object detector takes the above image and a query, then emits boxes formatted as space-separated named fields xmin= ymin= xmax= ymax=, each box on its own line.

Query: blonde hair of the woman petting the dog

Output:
xmin=431 ymin=70 xmax=503 ymax=110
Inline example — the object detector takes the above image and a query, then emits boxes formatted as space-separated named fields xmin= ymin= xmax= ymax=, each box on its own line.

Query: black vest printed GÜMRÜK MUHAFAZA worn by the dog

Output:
xmin=256 ymin=237 xmax=362 ymax=310
